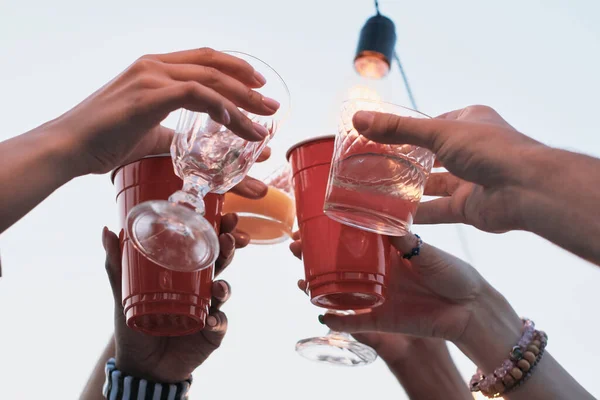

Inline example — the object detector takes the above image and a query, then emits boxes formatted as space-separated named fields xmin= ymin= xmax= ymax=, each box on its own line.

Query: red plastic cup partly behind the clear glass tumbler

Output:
xmin=287 ymin=136 xmax=390 ymax=310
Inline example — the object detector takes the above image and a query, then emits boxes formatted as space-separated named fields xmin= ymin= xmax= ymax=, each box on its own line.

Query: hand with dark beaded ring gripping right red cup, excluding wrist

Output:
xmin=290 ymin=232 xmax=487 ymax=340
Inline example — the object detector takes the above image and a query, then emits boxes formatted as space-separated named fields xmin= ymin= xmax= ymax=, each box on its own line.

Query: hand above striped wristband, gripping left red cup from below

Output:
xmin=102 ymin=177 xmax=269 ymax=383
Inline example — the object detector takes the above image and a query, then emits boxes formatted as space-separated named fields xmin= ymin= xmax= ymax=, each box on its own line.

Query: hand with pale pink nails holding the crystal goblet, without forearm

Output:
xmin=56 ymin=48 xmax=279 ymax=175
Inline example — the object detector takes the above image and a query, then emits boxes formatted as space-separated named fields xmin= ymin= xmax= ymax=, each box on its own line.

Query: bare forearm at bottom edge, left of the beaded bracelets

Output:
xmin=388 ymin=340 xmax=473 ymax=400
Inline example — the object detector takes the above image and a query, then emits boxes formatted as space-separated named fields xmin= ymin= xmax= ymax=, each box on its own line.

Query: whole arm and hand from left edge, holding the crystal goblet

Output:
xmin=0 ymin=49 xmax=279 ymax=233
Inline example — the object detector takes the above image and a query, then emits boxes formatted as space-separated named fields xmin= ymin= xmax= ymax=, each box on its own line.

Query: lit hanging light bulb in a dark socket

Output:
xmin=354 ymin=13 xmax=396 ymax=79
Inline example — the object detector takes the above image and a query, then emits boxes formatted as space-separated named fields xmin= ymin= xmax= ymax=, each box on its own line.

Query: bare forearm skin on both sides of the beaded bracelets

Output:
xmin=456 ymin=287 xmax=594 ymax=400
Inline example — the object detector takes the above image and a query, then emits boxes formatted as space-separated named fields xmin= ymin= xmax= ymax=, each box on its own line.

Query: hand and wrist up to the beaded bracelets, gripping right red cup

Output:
xmin=290 ymin=228 xmax=521 ymax=362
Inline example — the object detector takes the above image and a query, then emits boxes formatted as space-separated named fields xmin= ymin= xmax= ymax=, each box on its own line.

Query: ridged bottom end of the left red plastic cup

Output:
xmin=125 ymin=302 xmax=208 ymax=336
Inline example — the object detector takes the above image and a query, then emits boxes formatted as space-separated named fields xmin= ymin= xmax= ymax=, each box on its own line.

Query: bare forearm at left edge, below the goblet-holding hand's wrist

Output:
xmin=0 ymin=122 xmax=74 ymax=233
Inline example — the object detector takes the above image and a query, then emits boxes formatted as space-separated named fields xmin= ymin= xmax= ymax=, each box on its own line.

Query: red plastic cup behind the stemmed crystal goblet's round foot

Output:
xmin=112 ymin=155 xmax=223 ymax=336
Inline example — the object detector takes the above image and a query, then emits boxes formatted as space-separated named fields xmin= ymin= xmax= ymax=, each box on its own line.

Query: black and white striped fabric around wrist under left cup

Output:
xmin=102 ymin=358 xmax=192 ymax=400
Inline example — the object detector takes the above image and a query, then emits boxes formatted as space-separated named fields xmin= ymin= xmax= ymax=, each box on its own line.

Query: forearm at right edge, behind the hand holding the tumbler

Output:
xmin=519 ymin=147 xmax=600 ymax=265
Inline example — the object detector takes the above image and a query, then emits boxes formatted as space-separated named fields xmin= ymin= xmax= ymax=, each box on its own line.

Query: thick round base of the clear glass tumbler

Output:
xmin=323 ymin=203 xmax=412 ymax=236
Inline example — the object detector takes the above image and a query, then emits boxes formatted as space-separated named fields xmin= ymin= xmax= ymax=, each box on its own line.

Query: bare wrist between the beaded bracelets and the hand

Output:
xmin=455 ymin=284 xmax=523 ymax=374
